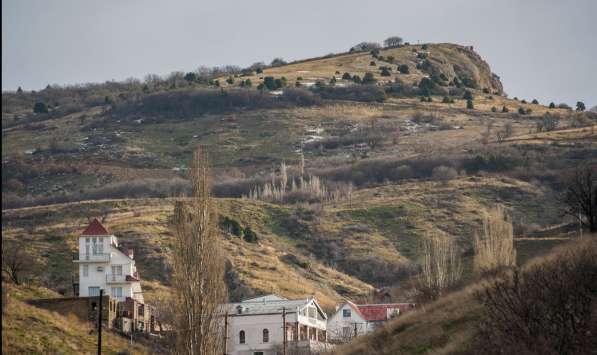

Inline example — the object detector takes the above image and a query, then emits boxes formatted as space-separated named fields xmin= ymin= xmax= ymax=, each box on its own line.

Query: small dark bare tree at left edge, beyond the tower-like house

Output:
xmin=2 ymin=240 xmax=37 ymax=285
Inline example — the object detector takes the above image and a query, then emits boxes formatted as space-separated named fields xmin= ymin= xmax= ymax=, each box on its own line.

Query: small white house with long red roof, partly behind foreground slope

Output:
xmin=327 ymin=300 xmax=414 ymax=343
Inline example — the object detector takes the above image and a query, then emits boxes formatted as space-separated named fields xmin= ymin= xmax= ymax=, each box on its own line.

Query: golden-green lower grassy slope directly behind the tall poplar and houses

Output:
xmin=2 ymin=178 xmax=559 ymax=307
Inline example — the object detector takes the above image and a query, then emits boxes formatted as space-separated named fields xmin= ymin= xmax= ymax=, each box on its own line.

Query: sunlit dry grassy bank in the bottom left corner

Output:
xmin=2 ymin=285 xmax=148 ymax=354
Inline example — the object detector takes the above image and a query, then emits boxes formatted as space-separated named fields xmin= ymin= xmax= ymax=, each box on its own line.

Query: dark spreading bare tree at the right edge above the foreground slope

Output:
xmin=563 ymin=165 xmax=597 ymax=233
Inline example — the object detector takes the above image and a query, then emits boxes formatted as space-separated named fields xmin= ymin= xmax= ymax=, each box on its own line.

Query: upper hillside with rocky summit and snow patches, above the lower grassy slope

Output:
xmin=2 ymin=44 xmax=594 ymax=208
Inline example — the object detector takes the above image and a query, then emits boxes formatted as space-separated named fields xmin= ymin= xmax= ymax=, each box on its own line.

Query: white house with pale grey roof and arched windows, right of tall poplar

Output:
xmin=226 ymin=295 xmax=329 ymax=355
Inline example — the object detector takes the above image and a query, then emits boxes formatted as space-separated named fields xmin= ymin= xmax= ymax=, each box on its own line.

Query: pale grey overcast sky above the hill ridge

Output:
xmin=2 ymin=0 xmax=597 ymax=106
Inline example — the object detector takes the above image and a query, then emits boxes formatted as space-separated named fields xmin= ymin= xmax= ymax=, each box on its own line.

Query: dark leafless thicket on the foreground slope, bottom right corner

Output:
xmin=472 ymin=240 xmax=597 ymax=354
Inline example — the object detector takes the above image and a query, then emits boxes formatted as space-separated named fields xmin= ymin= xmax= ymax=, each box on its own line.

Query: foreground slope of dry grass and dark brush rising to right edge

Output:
xmin=335 ymin=235 xmax=597 ymax=354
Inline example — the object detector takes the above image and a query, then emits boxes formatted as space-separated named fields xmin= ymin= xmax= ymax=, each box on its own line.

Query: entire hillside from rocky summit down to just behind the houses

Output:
xmin=2 ymin=44 xmax=597 ymax=349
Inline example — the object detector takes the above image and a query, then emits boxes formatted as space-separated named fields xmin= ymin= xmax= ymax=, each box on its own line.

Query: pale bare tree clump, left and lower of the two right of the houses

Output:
xmin=417 ymin=232 xmax=462 ymax=299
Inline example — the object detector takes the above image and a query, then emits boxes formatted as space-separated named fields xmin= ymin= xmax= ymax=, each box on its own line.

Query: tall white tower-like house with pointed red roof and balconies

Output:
xmin=73 ymin=219 xmax=144 ymax=303
